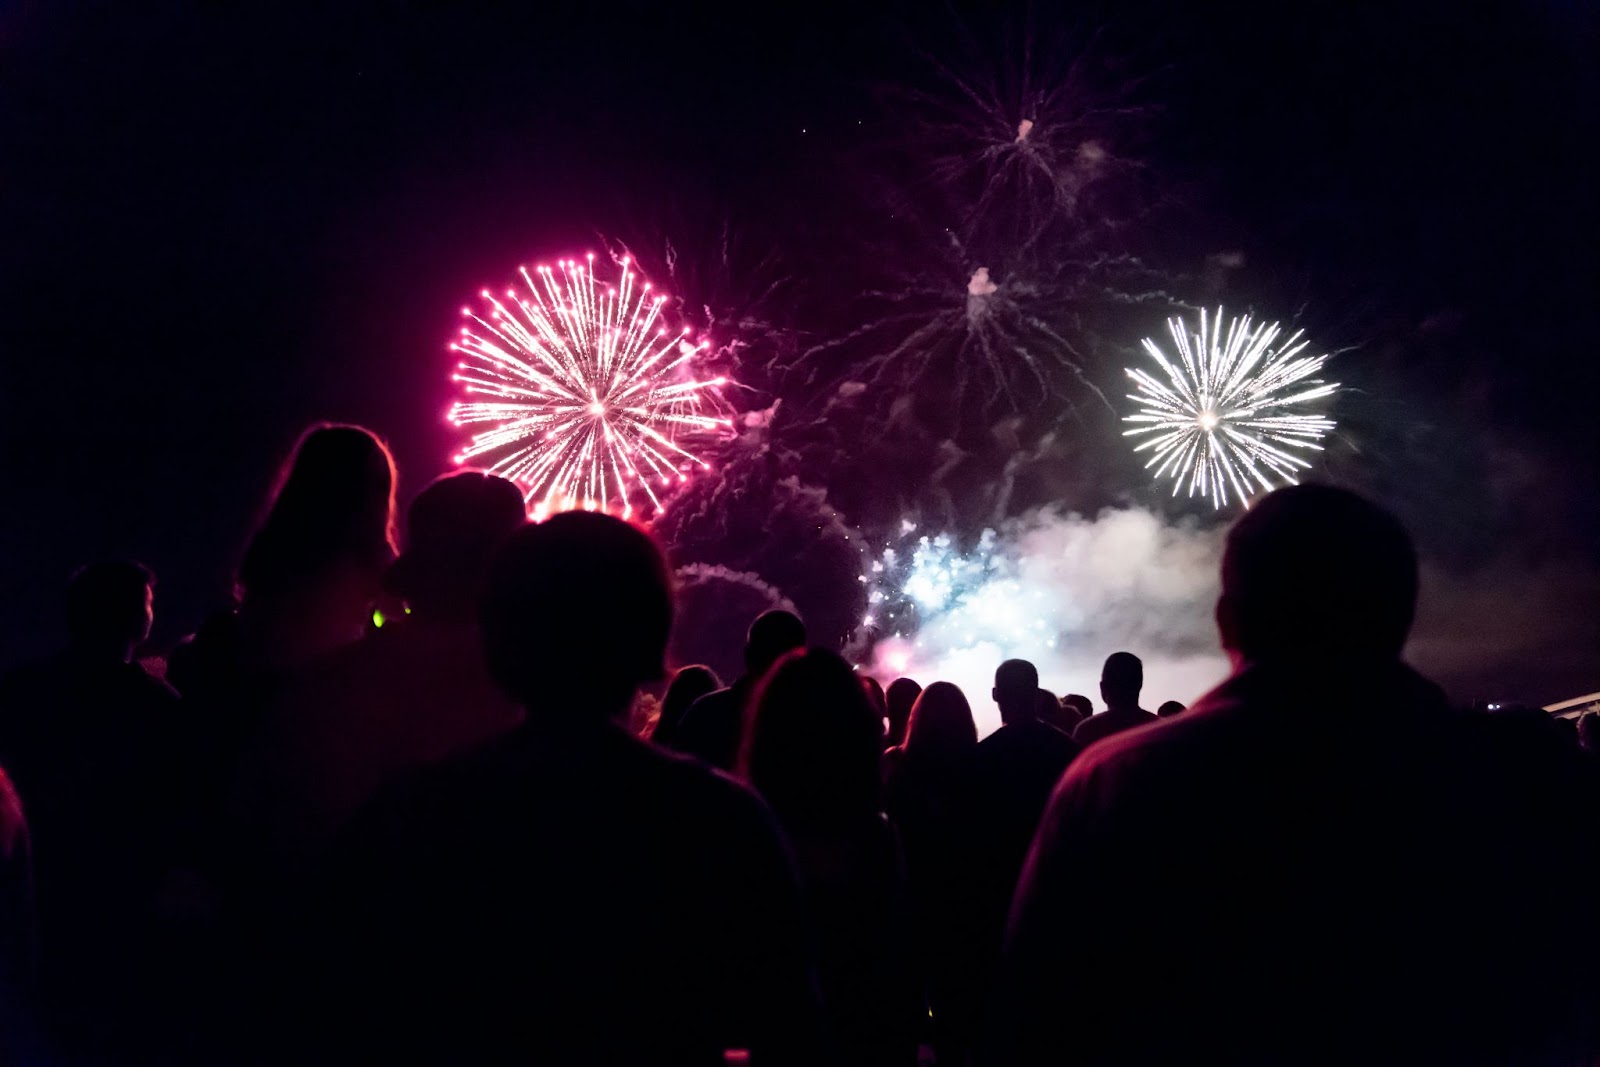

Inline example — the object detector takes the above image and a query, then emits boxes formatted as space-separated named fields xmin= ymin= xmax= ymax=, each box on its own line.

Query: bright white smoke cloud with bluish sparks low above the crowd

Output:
xmin=872 ymin=509 xmax=1227 ymax=734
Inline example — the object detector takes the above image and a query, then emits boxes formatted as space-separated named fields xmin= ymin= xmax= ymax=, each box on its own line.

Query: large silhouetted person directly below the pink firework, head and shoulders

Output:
xmin=305 ymin=512 xmax=822 ymax=1064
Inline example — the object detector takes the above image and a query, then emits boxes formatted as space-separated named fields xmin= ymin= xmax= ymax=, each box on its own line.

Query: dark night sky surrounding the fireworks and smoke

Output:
xmin=0 ymin=0 xmax=1600 ymax=696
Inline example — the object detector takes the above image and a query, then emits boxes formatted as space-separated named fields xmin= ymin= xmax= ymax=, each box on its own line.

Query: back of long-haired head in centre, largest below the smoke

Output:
xmin=742 ymin=648 xmax=882 ymax=829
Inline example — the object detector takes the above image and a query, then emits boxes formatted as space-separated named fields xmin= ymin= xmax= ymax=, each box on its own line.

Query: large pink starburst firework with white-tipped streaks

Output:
xmin=450 ymin=256 xmax=731 ymax=518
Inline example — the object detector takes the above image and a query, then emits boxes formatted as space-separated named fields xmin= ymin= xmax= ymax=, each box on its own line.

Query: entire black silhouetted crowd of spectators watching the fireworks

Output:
xmin=0 ymin=426 xmax=1600 ymax=1067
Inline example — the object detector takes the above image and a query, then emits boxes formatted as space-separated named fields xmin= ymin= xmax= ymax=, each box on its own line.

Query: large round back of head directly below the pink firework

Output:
xmin=478 ymin=512 xmax=672 ymax=721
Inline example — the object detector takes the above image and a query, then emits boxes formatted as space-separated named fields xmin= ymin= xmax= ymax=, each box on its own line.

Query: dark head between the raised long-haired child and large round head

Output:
xmin=384 ymin=470 xmax=526 ymax=621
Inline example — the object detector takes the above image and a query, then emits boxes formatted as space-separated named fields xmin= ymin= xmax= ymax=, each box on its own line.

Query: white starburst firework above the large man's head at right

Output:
xmin=1125 ymin=307 xmax=1338 ymax=509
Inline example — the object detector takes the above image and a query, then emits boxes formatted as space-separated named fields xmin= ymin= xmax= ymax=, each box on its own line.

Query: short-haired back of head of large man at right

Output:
xmin=1218 ymin=485 xmax=1416 ymax=659
